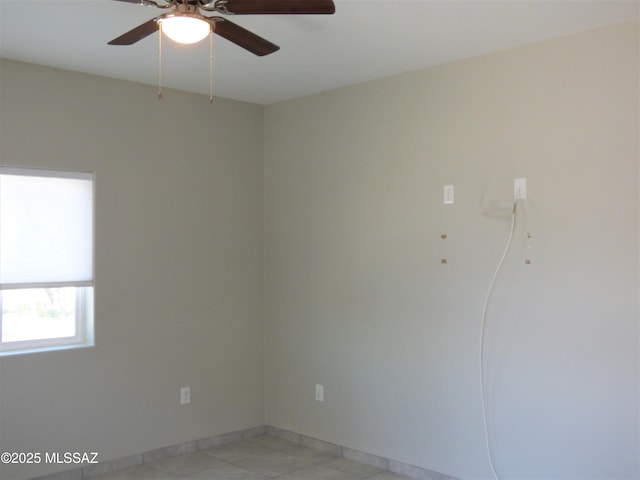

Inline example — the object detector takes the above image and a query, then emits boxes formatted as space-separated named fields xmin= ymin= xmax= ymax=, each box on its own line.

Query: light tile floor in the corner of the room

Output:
xmin=91 ymin=435 xmax=407 ymax=480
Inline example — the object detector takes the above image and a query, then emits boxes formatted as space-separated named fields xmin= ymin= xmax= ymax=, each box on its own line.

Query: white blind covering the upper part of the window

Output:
xmin=0 ymin=167 xmax=93 ymax=289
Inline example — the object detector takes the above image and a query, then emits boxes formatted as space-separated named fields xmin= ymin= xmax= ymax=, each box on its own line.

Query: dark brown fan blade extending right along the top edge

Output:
xmin=215 ymin=0 xmax=336 ymax=15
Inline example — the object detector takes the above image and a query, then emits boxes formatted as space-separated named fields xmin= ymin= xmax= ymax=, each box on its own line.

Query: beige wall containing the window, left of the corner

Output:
xmin=0 ymin=61 xmax=264 ymax=479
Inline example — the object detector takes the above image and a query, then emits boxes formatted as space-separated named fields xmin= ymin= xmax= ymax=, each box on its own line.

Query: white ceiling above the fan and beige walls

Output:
xmin=0 ymin=0 xmax=640 ymax=105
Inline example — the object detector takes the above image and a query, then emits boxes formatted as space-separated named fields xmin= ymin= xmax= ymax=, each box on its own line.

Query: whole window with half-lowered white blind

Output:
xmin=0 ymin=166 xmax=93 ymax=355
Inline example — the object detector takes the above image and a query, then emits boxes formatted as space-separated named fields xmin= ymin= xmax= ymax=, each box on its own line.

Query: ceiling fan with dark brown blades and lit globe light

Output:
xmin=109 ymin=0 xmax=335 ymax=56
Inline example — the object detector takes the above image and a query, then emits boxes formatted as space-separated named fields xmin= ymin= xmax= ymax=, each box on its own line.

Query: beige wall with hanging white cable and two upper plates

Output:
xmin=265 ymin=20 xmax=640 ymax=480
